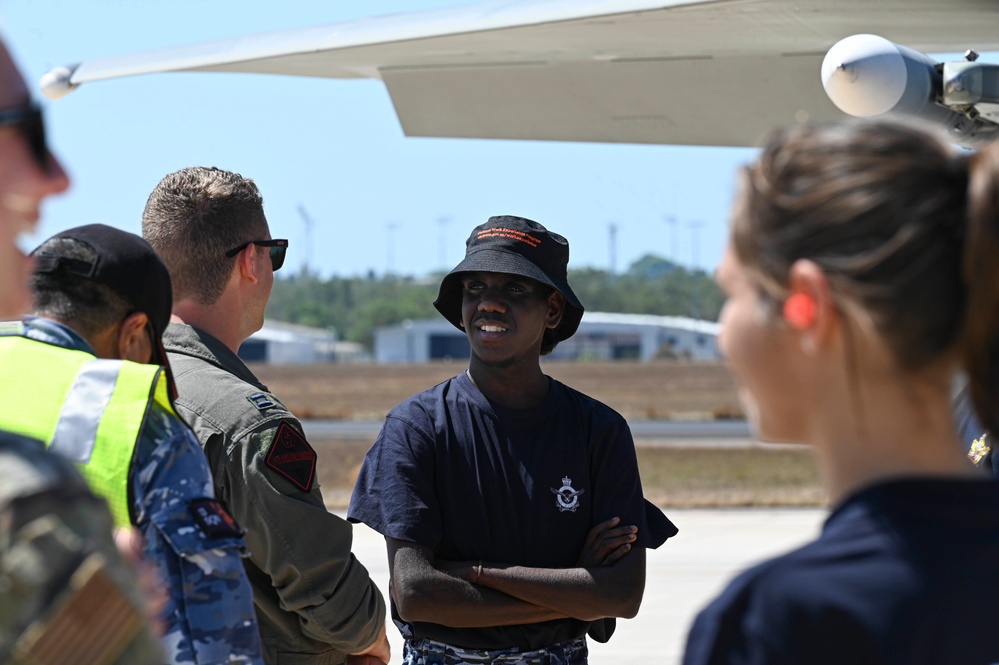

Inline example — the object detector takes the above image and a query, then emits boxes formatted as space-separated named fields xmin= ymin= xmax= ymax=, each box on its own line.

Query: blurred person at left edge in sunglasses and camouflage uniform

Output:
xmin=0 ymin=35 xmax=163 ymax=665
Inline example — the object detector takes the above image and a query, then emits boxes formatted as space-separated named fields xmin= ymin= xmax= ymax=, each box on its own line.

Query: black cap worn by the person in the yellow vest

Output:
xmin=32 ymin=224 xmax=173 ymax=394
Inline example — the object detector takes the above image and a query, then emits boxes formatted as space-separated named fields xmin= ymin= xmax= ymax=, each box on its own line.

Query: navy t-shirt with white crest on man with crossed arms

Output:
xmin=348 ymin=373 xmax=676 ymax=649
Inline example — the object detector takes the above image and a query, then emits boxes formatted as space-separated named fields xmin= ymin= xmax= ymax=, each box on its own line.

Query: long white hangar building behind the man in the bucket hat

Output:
xmin=375 ymin=312 xmax=720 ymax=363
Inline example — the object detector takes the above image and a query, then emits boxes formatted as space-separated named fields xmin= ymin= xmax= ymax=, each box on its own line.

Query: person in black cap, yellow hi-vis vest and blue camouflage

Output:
xmin=0 ymin=224 xmax=263 ymax=665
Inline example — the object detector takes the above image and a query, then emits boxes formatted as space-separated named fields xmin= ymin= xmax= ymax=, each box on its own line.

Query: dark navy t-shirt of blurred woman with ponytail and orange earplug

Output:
xmin=683 ymin=479 xmax=999 ymax=665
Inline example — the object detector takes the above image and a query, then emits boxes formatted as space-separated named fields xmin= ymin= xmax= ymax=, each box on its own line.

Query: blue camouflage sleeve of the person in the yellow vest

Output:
xmin=131 ymin=403 xmax=264 ymax=665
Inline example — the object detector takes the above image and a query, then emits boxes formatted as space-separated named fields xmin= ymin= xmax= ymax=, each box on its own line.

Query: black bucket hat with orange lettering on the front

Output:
xmin=434 ymin=215 xmax=583 ymax=342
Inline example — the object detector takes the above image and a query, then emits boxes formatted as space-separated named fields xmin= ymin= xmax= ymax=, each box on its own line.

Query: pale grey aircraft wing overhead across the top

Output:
xmin=46 ymin=0 xmax=999 ymax=146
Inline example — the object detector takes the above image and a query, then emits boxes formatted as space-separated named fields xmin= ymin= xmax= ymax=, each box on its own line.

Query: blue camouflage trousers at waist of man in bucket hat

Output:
xmin=402 ymin=637 xmax=589 ymax=665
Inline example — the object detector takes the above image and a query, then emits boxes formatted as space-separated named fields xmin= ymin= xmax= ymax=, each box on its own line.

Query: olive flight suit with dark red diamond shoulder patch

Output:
xmin=163 ymin=323 xmax=385 ymax=665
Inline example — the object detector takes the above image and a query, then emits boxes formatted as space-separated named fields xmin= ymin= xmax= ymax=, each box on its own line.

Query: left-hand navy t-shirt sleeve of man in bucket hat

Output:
xmin=347 ymin=410 xmax=443 ymax=548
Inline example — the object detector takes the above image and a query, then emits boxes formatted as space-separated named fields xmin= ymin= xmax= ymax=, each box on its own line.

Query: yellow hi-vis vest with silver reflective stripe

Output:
xmin=0 ymin=324 xmax=175 ymax=526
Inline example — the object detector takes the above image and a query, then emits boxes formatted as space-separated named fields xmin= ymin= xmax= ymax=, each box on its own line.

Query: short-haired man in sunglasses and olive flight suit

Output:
xmin=142 ymin=167 xmax=390 ymax=665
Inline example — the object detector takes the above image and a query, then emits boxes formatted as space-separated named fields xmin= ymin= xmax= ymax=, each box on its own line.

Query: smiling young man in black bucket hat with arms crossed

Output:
xmin=348 ymin=216 xmax=676 ymax=665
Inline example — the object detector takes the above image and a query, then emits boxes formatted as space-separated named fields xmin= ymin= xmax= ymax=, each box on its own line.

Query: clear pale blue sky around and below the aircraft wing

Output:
xmin=0 ymin=0 xmax=984 ymax=276
